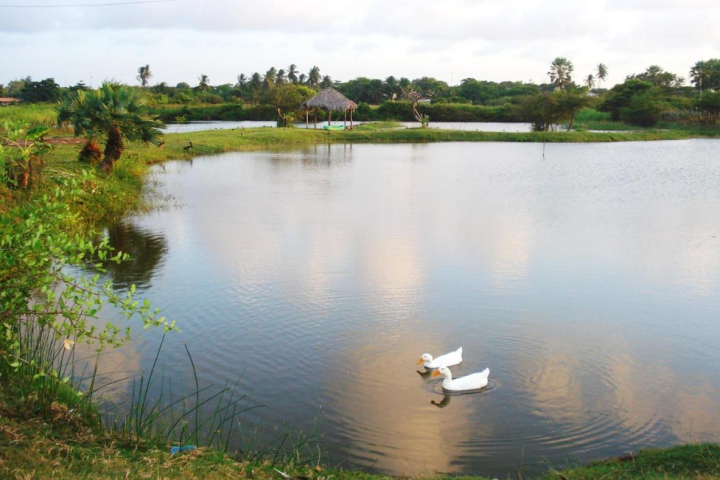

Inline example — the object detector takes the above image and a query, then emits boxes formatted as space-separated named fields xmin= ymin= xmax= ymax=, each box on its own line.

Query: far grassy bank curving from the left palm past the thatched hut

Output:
xmin=9 ymin=122 xmax=720 ymax=225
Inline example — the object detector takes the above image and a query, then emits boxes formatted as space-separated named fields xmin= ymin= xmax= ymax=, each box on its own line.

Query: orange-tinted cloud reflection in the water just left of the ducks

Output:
xmin=326 ymin=344 xmax=477 ymax=474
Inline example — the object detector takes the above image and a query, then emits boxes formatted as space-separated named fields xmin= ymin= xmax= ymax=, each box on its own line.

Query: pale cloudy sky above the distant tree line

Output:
xmin=0 ymin=0 xmax=720 ymax=85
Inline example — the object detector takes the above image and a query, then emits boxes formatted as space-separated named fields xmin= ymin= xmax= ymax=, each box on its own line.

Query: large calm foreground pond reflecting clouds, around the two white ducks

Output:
xmin=100 ymin=140 xmax=720 ymax=476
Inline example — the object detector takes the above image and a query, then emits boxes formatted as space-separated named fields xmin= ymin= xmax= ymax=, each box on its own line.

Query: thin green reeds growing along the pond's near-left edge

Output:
xmin=18 ymin=328 xmax=326 ymax=468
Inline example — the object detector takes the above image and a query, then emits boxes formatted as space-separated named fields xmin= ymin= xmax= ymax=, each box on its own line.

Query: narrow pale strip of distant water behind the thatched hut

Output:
xmin=163 ymin=120 xmax=531 ymax=133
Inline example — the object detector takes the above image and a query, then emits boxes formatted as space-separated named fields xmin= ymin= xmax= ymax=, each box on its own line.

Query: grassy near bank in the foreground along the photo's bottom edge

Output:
xmin=0 ymin=398 xmax=720 ymax=480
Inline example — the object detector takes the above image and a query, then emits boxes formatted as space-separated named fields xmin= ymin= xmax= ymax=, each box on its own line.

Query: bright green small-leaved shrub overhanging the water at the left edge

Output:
xmin=0 ymin=173 xmax=175 ymax=406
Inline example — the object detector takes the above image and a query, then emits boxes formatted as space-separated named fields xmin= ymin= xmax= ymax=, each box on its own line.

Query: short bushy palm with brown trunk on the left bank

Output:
xmin=56 ymin=82 xmax=164 ymax=172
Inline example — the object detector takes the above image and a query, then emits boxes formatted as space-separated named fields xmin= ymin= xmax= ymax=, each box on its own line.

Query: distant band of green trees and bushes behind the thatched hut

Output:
xmin=0 ymin=57 xmax=720 ymax=130
